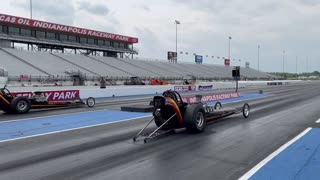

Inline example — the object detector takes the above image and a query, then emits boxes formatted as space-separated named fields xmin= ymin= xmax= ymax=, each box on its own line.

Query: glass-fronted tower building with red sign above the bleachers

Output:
xmin=0 ymin=14 xmax=139 ymax=58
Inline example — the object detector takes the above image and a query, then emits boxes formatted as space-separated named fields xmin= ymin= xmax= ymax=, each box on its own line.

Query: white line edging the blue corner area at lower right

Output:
xmin=238 ymin=128 xmax=312 ymax=180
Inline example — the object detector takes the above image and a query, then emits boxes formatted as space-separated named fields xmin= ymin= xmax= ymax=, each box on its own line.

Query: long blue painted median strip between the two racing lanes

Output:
xmin=0 ymin=94 xmax=270 ymax=142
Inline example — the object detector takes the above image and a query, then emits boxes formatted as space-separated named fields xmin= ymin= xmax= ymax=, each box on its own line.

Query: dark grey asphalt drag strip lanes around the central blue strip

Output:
xmin=0 ymin=82 xmax=320 ymax=180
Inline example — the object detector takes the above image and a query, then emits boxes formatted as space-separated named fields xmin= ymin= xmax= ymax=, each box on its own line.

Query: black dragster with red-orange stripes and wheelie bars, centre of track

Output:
xmin=133 ymin=90 xmax=250 ymax=143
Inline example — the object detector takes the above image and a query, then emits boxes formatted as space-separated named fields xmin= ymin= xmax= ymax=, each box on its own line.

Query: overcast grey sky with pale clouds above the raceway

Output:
xmin=0 ymin=0 xmax=320 ymax=72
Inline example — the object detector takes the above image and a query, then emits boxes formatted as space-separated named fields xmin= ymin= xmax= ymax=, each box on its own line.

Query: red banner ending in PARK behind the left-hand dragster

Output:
xmin=11 ymin=90 xmax=80 ymax=101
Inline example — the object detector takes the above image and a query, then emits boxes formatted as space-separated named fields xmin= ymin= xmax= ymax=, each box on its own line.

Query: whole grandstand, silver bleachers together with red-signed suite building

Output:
xmin=0 ymin=14 xmax=275 ymax=85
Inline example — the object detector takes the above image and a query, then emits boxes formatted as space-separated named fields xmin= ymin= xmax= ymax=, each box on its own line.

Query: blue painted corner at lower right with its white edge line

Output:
xmin=239 ymin=128 xmax=320 ymax=180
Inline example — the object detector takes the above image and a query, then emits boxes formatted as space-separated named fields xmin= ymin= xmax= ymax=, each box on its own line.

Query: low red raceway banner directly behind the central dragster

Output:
xmin=182 ymin=92 xmax=240 ymax=103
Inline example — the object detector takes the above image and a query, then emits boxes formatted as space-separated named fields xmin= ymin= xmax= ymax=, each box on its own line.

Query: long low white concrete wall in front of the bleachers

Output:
xmin=8 ymin=81 xmax=301 ymax=99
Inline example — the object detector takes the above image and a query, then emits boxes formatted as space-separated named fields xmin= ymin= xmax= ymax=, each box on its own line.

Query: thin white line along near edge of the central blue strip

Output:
xmin=0 ymin=115 xmax=152 ymax=143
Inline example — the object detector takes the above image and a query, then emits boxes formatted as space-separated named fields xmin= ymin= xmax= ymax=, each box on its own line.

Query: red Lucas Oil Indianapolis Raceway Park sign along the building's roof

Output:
xmin=0 ymin=14 xmax=139 ymax=43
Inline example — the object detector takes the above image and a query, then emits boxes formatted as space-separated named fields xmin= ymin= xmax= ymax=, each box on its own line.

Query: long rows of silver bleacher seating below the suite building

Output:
xmin=0 ymin=48 xmax=275 ymax=80
